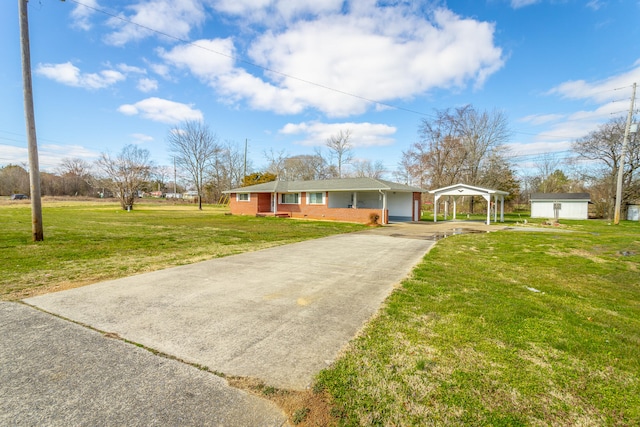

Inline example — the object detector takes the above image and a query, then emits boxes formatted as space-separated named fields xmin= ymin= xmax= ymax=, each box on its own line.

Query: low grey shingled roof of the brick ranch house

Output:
xmin=223 ymin=178 xmax=424 ymax=194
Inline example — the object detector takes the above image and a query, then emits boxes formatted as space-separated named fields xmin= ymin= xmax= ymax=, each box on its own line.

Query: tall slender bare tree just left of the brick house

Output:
xmin=167 ymin=121 xmax=220 ymax=210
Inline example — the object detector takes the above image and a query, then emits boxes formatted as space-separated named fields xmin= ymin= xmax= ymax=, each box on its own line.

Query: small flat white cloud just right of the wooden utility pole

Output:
xmin=36 ymin=62 xmax=126 ymax=89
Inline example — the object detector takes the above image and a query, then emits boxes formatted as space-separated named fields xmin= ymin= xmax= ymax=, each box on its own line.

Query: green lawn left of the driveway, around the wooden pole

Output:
xmin=0 ymin=200 xmax=364 ymax=300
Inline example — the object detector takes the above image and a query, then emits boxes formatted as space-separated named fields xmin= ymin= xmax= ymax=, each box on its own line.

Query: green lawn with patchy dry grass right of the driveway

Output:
xmin=316 ymin=221 xmax=640 ymax=426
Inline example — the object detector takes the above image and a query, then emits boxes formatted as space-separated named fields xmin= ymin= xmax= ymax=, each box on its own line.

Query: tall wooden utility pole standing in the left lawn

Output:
xmin=18 ymin=0 xmax=44 ymax=242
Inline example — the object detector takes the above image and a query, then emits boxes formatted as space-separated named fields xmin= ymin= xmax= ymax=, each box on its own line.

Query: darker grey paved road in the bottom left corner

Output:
xmin=0 ymin=302 xmax=286 ymax=427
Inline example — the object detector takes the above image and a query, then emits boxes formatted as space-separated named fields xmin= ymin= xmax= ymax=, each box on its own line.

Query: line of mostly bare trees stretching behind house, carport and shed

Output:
xmin=0 ymin=105 xmax=640 ymax=218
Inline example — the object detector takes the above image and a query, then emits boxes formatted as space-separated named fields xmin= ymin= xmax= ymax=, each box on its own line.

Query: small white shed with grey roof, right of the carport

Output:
xmin=530 ymin=193 xmax=591 ymax=219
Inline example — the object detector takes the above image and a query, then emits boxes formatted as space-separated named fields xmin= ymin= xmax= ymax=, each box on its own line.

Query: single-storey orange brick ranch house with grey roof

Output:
xmin=224 ymin=178 xmax=423 ymax=224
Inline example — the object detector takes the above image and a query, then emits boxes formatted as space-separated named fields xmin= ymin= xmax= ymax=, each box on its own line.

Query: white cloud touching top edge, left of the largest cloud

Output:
xmin=105 ymin=0 xmax=205 ymax=46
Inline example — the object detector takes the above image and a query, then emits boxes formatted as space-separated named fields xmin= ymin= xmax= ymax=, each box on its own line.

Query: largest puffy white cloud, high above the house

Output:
xmin=160 ymin=5 xmax=504 ymax=117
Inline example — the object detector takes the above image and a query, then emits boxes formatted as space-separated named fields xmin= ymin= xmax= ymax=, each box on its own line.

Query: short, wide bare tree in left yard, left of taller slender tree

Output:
xmin=96 ymin=145 xmax=151 ymax=210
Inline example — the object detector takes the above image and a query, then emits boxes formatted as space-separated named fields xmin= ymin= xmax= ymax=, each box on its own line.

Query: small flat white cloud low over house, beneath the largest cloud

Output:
xmin=279 ymin=122 xmax=397 ymax=148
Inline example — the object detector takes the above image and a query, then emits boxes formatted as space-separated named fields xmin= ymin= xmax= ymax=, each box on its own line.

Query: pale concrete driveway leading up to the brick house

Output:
xmin=25 ymin=224 xmax=436 ymax=389
